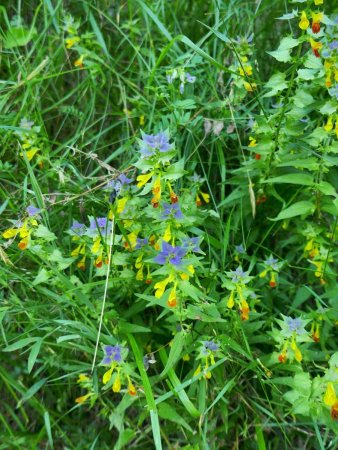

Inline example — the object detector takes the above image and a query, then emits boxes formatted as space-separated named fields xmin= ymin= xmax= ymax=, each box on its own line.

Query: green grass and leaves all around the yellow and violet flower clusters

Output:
xmin=0 ymin=0 xmax=338 ymax=450
